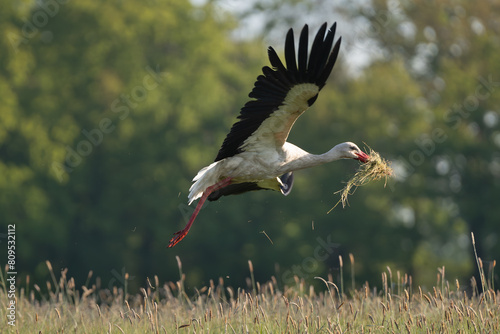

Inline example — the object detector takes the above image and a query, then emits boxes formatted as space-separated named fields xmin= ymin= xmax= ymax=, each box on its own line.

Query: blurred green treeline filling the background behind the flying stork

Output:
xmin=0 ymin=0 xmax=500 ymax=288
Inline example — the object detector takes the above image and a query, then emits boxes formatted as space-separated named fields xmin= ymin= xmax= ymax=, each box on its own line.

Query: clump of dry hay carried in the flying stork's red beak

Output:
xmin=328 ymin=147 xmax=393 ymax=213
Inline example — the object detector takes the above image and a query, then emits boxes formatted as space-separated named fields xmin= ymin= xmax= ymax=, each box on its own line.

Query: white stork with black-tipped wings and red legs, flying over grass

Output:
xmin=168 ymin=23 xmax=369 ymax=247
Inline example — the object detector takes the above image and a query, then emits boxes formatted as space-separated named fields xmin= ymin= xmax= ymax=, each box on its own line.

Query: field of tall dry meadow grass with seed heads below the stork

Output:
xmin=0 ymin=239 xmax=500 ymax=333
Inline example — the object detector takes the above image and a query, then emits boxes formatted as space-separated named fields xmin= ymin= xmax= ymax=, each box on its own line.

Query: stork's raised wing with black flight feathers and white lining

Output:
xmin=215 ymin=23 xmax=341 ymax=161
